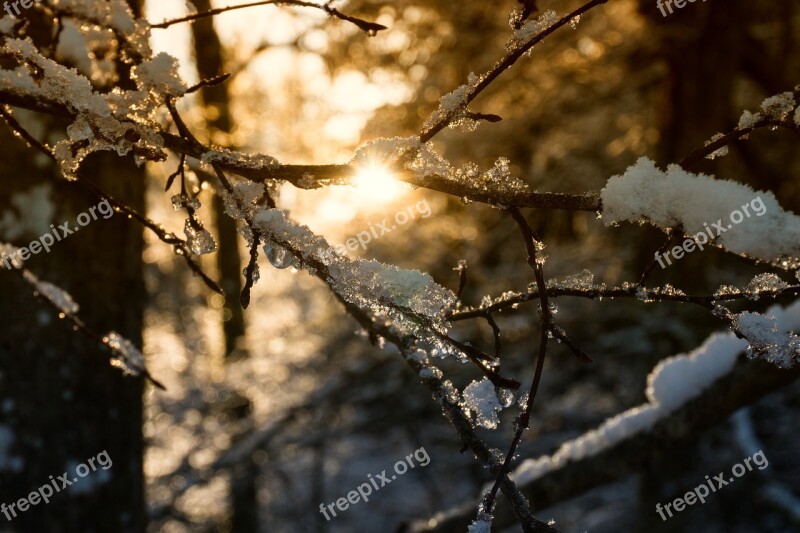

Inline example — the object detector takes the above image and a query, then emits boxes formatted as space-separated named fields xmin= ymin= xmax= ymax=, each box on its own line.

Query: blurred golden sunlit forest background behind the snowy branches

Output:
xmin=0 ymin=0 xmax=800 ymax=533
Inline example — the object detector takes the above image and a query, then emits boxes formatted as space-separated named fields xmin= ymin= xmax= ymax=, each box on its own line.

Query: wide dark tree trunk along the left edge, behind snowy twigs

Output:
xmin=0 ymin=142 xmax=146 ymax=532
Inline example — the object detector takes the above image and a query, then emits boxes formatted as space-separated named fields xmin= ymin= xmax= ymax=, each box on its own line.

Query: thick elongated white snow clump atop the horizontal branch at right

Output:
xmin=601 ymin=157 xmax=800 ymax=262
